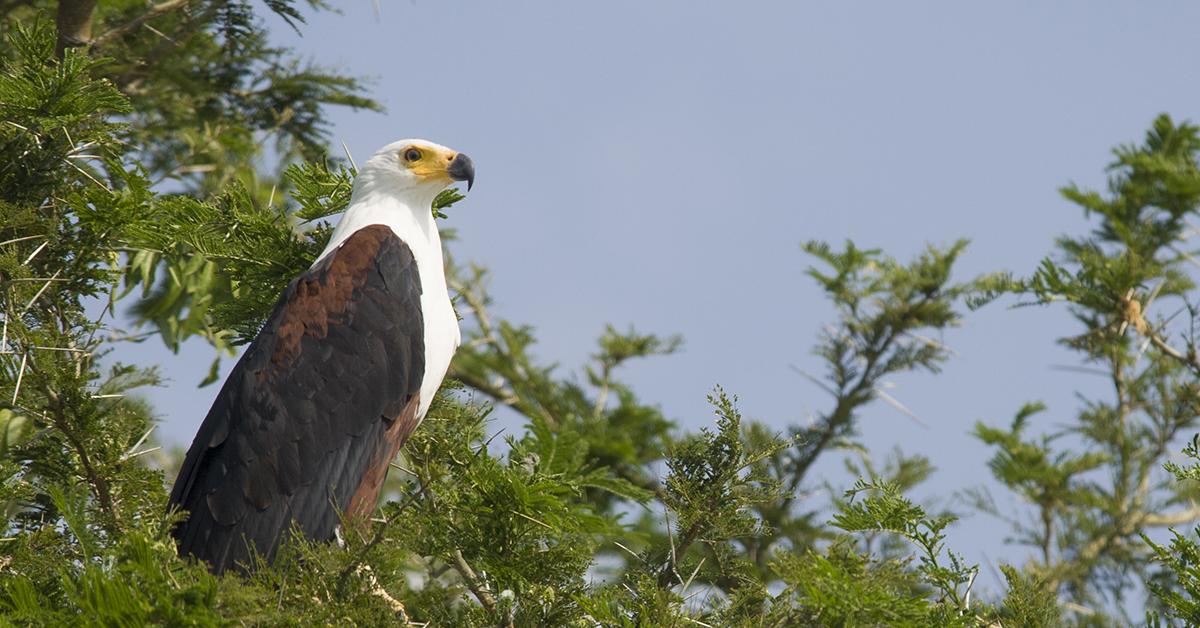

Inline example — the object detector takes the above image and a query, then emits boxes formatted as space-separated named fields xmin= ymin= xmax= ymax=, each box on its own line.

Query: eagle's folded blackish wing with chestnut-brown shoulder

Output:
xmin=170 ymin=225 xmax=425 ymax=573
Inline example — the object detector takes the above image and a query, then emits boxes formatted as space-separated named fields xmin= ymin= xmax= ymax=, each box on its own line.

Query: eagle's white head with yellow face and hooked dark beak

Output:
xmin=354 ymin=139 xmax=475 ymax=209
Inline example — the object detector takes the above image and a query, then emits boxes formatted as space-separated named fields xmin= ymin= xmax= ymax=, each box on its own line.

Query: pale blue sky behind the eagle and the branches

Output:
xmin=119 ymin=0 xmax=1200 ymax=605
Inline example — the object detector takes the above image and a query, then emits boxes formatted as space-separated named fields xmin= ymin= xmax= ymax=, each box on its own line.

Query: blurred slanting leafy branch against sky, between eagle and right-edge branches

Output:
xmin=744 ymin=241 xmax=980 ymax=575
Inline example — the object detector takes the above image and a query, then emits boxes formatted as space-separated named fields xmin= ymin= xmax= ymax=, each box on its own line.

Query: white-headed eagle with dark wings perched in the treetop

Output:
xmin=170 ymin=139 xmax=475 ymax=574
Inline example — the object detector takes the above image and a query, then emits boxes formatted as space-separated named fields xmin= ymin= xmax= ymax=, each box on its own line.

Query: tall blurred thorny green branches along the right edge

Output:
xmin=974 ymin=115 xmax=1200 ymax=622
